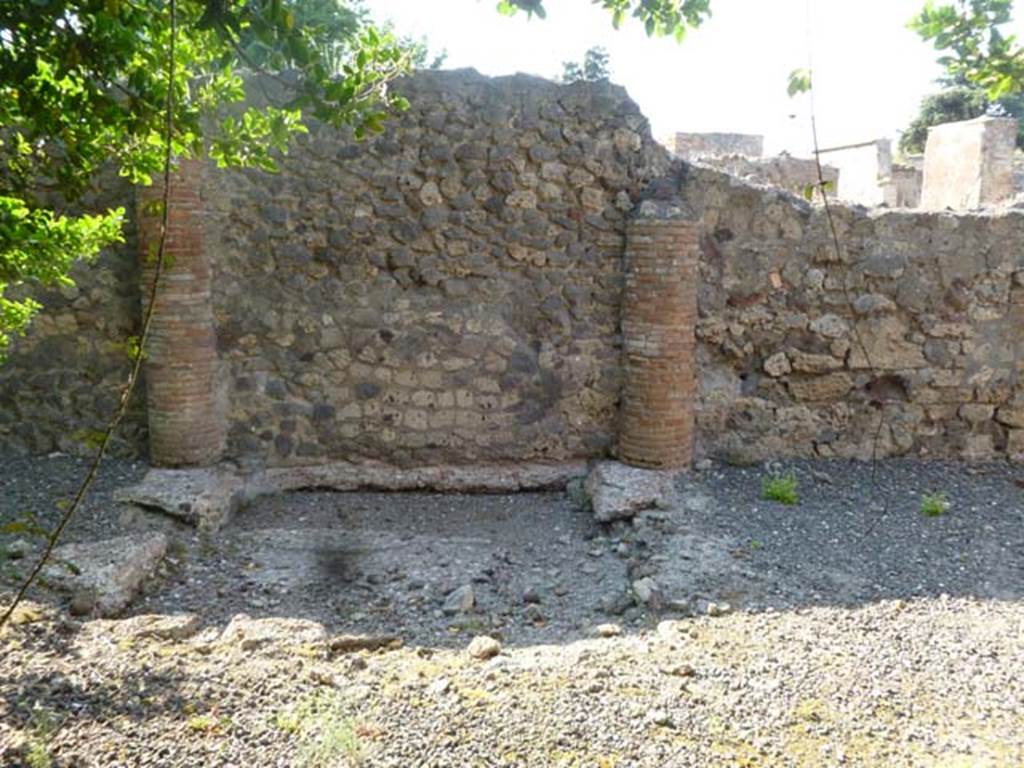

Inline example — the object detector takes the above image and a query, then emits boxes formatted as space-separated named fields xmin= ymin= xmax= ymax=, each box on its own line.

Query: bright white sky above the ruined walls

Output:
xmin=367 ymin=0 xmax=1024 ymax=155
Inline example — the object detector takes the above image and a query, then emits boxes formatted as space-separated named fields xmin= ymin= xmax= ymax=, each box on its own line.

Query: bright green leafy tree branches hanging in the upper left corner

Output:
xmin=0 ymin=0 xmax=414 ymax=354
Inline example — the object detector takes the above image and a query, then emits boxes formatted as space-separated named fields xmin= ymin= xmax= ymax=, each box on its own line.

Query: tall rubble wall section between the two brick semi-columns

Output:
xmin=204 ymin=72 xmax=668 ymax=465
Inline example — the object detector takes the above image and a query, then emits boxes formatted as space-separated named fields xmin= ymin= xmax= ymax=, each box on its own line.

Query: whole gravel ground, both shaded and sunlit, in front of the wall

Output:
xmin=0 ymin=458 xmax=1024 ymax=768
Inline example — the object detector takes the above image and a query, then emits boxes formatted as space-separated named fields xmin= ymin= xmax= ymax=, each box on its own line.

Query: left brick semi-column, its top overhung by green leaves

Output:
xmin=136 ymin=160 xmax=225 ymax=467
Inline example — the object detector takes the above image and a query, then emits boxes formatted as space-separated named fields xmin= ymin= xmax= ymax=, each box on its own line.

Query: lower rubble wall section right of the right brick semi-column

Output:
xmin=684 ymin=170 xmax=1024 ymax=460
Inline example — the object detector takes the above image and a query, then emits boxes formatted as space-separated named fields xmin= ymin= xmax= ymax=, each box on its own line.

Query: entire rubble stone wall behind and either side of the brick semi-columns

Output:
xmin=0 ymin=72 xmax=1024 ymax=467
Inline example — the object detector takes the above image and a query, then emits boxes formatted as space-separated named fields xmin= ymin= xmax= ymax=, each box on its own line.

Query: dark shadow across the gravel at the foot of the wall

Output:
xmin=105 ymin=461 xmax=1024 ymax=646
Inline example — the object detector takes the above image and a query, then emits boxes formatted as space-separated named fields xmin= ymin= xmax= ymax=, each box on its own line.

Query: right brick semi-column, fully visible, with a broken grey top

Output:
xmin=618 ymin=202 xmax=699 ymax=469
